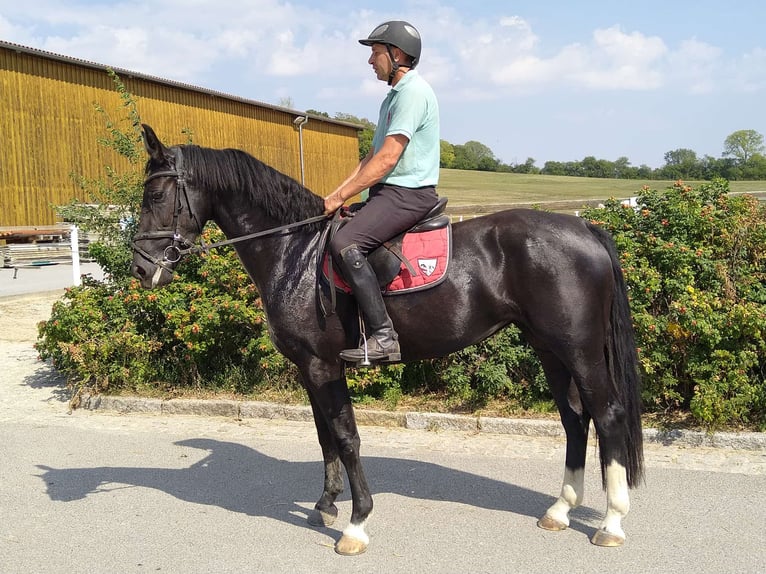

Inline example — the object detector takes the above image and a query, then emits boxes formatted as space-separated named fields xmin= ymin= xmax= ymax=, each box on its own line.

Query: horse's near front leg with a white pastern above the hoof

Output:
xmin=306 ymin=376 xmax=372 ymax=556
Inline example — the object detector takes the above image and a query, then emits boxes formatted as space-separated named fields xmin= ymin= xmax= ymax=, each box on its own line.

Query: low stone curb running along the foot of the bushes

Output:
xmin=81 ymin=395 xmax=766 ymax=450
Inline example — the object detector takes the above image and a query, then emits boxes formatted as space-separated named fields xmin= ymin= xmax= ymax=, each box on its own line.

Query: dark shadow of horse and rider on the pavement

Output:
xmin=38 ymin=439 xmax=599 ymax=534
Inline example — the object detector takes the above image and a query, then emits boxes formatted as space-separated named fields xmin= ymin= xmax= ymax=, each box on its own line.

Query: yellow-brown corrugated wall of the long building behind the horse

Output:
xmin=0 ymin=46 xmax=358 ymax=227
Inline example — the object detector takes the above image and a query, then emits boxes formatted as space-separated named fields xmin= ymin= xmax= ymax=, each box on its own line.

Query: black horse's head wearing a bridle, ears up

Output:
xmin=132 ymin=124 xmax=209 ymax=288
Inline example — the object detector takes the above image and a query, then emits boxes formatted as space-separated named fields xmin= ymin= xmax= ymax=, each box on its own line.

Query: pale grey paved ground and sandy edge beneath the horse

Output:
xmin=0 ymin=276 xmax=766 ymax=574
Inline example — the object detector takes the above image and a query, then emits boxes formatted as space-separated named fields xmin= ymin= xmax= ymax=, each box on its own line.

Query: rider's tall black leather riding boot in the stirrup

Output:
xmin=340 ymin=245 xmax=401 ymax=363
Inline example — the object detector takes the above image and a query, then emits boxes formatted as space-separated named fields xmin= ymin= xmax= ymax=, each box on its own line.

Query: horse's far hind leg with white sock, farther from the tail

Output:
xmin=537 ymin=350 xmax=590 ymax=530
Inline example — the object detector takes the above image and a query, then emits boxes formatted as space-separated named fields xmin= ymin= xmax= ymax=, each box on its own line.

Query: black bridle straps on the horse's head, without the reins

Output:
xmin=132 ymin=148 xmax=202 ymax=273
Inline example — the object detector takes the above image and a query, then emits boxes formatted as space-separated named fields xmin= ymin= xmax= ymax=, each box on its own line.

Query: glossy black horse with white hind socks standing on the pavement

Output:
xmin=133 ymin=125 xmax=643 ymax=554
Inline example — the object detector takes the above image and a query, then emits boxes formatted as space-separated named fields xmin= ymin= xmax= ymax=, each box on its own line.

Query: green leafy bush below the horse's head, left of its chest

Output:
xmin=36 ymin=225 xmax=295 ymax=404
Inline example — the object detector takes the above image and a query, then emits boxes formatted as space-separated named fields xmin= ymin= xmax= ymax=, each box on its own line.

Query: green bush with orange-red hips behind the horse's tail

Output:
xmin=583 ymin=180 xmax=766 ymax=428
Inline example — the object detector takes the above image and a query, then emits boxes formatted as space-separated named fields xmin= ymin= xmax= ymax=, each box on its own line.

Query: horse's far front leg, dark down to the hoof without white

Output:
xmin=306 ymin=386 xmax=343 ymax=526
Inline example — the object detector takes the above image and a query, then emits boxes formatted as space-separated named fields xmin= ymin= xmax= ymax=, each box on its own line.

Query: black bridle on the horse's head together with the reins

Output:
xmin=132 ymin=148 xmax=330 ymax=273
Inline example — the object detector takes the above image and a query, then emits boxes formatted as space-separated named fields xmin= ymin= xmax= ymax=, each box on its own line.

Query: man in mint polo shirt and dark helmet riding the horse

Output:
xmin=325 ymin=20 xmax=440 ymax=362
